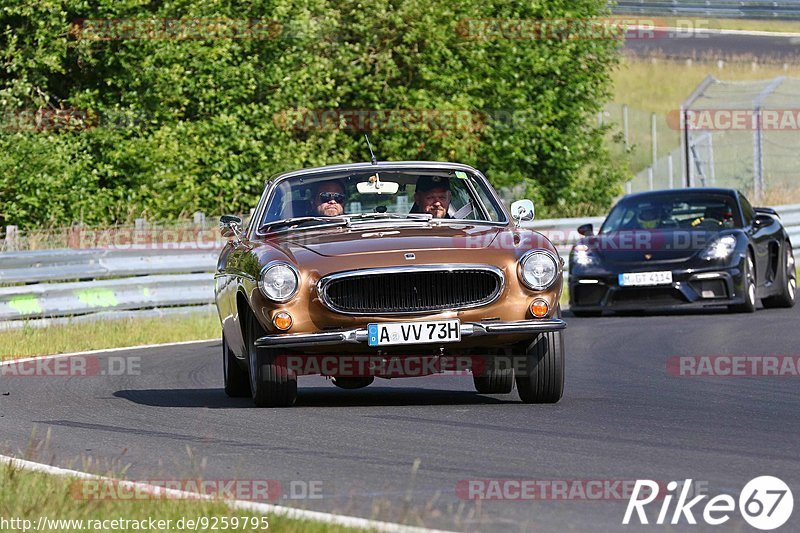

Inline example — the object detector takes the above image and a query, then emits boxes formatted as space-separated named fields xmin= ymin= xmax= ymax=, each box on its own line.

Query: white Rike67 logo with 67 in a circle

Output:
xmin=622 ymin=476 xmax=794 ymax=531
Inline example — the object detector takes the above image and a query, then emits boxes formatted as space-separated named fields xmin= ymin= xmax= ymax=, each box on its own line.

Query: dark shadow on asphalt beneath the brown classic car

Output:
xmin=114 ymin=382 xmax=519 ymax=409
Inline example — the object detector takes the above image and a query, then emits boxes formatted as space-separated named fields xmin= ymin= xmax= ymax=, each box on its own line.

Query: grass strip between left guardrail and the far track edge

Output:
xmin=0 ymin=311 xmax=221 ymax=360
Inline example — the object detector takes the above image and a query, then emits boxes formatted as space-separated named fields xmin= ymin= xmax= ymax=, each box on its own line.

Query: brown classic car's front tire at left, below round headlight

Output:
xmin=245 ymin=312 xmax=297 ymax=407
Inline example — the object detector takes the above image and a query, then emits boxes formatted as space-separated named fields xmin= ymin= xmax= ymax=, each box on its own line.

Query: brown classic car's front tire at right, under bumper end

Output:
xmin=514 ymin=331 xmax=564 ymax=403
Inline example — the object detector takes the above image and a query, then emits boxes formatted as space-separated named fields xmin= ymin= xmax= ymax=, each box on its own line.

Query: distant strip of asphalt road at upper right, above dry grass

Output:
xmin=624 ymin=29 xmax=800 ymax=61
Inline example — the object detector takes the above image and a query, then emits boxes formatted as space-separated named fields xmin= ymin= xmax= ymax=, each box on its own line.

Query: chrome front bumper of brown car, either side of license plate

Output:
xmin=256 ymin=318 xmax=567 ymax=348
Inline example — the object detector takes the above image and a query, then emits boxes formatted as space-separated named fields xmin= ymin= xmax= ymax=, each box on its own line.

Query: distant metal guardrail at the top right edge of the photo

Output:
xmin=612 ymin=0 xmax=800 ymax=19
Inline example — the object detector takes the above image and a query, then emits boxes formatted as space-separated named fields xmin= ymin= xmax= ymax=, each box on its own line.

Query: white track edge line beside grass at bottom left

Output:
xmin=0 ymin=455 xmax=449 ymax=533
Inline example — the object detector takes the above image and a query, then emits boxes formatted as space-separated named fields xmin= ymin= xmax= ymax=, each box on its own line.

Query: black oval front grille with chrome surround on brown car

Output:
xmin=319 ymin=266 xmax=504 ymax=315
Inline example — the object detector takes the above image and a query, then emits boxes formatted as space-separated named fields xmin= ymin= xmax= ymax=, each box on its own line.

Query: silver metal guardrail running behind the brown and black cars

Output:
xmin=0 ymin=204 xmax=800 ymax=329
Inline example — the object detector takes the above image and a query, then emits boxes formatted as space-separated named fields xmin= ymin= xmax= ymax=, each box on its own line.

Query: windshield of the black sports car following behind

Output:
xmin=600 ymin=193 xmax=742 ymax=233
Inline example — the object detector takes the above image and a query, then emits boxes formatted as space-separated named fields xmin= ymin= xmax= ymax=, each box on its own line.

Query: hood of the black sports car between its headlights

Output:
xmin=578 ymin=230 xmax=721 ymax=263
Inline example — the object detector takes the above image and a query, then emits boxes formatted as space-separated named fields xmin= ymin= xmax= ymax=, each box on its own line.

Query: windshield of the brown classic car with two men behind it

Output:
xmin=259 ymin=169 xmax=505 ymax=232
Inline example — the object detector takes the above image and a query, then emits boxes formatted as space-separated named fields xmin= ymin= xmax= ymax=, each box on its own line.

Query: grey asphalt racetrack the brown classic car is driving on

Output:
xmin=0 ymin=307 xmax=800 ymax=531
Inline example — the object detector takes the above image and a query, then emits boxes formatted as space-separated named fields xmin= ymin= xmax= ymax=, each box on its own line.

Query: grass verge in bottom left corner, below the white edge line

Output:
xmin=0 ymin=463 xmax=358 ymax=533
